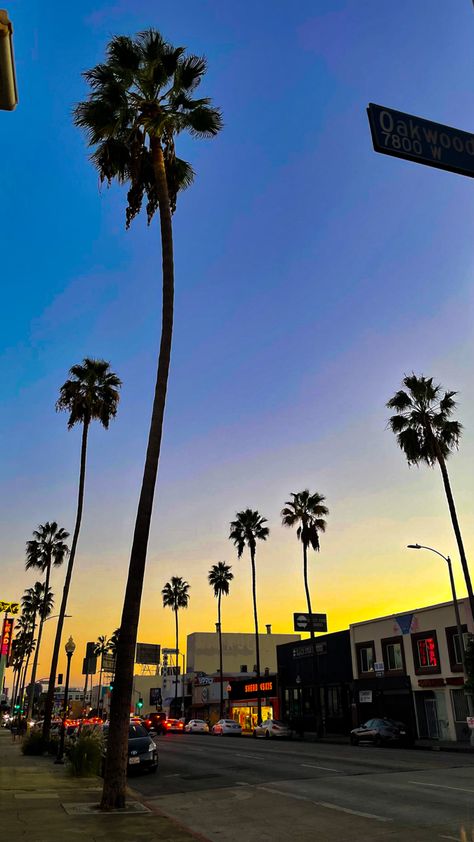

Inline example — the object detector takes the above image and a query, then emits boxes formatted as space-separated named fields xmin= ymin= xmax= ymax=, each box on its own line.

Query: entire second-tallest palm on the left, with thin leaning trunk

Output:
xmin=43 ymin=357 xmax=122 ymax=740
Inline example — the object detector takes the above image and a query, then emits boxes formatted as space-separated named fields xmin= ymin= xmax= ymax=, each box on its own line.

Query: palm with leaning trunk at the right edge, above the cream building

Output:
xmin=387 ymin=374 xmax=474 ymax=619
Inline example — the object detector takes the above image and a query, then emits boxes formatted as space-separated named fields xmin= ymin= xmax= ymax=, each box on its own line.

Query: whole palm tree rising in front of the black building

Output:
xmin=281 ymin=488 xmax=329 ymax=732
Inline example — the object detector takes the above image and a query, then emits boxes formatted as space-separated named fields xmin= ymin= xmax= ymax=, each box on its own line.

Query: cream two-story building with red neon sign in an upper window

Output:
xmin=350 ymin=599 xmax=474 ymax=741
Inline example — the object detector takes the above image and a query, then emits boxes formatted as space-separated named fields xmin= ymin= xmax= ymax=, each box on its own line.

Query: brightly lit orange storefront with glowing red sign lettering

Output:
xmin=229 ymin=675 xmax=280 ymax=731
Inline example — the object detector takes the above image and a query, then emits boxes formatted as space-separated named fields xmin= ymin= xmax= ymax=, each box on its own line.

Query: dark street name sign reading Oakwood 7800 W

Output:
xmin=367 ymin=102 xmax=474 ymax=178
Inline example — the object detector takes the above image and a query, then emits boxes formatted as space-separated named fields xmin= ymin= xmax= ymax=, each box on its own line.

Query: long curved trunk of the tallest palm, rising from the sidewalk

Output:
xmin=101 ymin=138 xmax=174 ymax=810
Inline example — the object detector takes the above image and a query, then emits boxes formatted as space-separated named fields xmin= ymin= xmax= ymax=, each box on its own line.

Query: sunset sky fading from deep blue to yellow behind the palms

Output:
xmin=0 ymin=0 xmax=474 ymax=681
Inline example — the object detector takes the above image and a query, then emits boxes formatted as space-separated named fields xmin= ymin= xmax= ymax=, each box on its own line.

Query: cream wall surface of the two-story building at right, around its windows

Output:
xmin=350 ymin=599 xmax=472 ymax=740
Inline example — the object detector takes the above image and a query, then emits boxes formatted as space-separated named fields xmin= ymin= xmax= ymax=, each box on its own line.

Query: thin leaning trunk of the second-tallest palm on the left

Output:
xmin=43 ymin=420 xmax=89 ymax=740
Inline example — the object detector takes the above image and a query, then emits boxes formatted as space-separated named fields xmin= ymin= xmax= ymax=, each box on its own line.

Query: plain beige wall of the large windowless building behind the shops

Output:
xmin=187 ymin=632 xmax=300 ymax=675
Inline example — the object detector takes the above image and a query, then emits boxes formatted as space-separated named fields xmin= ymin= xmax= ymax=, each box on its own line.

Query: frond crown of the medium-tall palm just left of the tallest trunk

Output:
xmin=56 ymin=357 xmax=122 ymax=430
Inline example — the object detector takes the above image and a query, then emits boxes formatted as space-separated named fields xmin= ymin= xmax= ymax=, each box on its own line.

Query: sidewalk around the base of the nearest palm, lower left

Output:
xmin=0 ymin=728 xmax=203 ymax=842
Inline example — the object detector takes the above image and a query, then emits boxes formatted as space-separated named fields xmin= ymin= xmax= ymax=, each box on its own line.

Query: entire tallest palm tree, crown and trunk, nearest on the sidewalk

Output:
xmin=75 ymin=29 xmax=222 ymax=810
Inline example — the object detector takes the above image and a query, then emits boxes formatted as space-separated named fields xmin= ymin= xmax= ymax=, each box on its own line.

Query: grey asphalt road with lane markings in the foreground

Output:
xmin=130 ymin=734 xmax=474 ymax=842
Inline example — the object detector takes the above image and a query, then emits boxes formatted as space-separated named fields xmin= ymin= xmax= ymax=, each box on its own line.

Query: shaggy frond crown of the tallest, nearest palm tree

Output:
xmin=74 ymin=29 xmax=222 ymax=221
